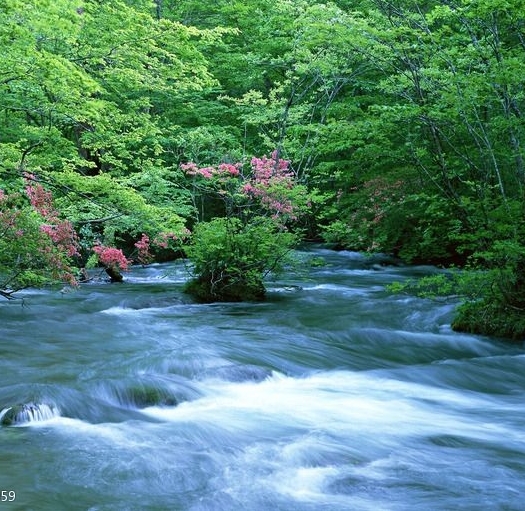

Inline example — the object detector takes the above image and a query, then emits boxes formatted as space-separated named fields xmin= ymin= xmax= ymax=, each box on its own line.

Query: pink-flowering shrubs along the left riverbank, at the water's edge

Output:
xmin=0 ymin=173 xmax=192 ymax=298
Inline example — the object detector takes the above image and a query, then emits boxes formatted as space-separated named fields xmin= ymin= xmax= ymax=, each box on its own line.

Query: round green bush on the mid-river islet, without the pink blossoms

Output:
xmin=186 ymin=217 xmax=297 ymax=302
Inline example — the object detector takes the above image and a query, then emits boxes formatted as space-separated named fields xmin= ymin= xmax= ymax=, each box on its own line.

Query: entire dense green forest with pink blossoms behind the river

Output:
xmin=0 ymin=0 xmax=525 ymax=339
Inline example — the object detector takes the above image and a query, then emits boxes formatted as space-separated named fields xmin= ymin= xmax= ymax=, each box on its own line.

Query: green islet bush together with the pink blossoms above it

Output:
xmin=181 ymin=152 xmax=308 ymax=302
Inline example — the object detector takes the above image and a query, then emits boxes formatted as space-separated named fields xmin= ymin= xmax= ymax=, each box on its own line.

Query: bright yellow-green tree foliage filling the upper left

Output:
xmin=0 ymin=0 xmax=213 ymax=250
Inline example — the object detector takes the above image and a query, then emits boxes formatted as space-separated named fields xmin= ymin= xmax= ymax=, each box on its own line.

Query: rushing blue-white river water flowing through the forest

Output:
xmin=0 ymin=248 xmax=525 ymax=511
